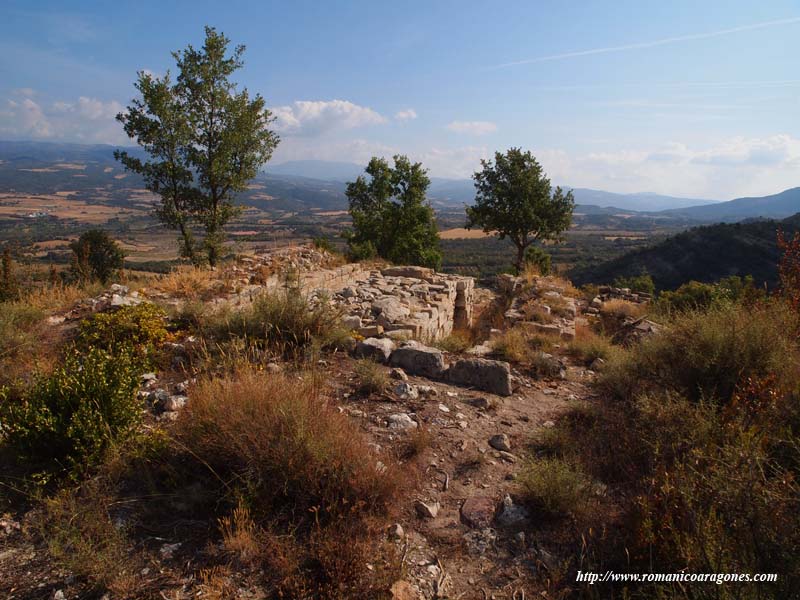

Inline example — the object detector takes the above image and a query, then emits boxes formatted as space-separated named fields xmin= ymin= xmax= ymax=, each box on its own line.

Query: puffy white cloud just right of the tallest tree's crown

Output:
xmin=270 ymin=100 xmax=386 ymax=136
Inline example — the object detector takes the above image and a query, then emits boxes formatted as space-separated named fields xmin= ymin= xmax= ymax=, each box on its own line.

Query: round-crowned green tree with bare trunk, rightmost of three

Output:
xmin=466 ymin=148 xmax=575 ymax=272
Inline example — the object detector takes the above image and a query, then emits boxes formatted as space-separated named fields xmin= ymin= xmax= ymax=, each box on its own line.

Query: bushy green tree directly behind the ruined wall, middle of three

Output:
xmin=346 ymin=155 xmax=442 ymax=269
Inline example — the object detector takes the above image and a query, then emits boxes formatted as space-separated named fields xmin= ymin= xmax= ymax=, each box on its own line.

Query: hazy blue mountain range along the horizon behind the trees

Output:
xmin=0 ymin=141 xmax=800 ymax=223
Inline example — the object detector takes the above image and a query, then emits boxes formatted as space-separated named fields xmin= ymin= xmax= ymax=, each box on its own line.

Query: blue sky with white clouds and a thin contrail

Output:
xmin=0 ymin=0 xmax=800 ymax=199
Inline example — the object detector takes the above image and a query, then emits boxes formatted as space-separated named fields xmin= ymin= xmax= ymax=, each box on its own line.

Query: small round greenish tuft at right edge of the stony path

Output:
xmin=518 ymin=458 xmax=588 ymax=516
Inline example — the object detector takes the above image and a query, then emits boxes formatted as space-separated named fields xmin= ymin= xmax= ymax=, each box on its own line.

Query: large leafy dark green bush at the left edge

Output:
xmin=0 ymin=348 xmax=142 ymax=474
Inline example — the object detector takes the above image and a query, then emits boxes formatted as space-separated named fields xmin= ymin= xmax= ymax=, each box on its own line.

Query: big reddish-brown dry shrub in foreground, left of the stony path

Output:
xmin=175 ymin=370 xmax=408 ymax=598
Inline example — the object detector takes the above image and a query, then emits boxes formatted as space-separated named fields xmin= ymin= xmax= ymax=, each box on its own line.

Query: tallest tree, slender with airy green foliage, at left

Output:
xmin=114 ymin=27 xmax=279 ymax=267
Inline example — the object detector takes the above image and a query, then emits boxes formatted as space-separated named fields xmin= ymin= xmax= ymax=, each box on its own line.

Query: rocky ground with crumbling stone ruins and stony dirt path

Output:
xmin=0 ymin=248 xmax=608 ymax=600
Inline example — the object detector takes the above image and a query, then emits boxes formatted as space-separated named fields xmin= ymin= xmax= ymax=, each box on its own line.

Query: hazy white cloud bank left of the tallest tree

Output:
xmin=0 ymin=90 xmax=128 ymax=144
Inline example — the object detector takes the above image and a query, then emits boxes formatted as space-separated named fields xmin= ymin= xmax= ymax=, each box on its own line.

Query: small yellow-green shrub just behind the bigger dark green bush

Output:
xmin=77 ymin=303 xmax=167 ymax=356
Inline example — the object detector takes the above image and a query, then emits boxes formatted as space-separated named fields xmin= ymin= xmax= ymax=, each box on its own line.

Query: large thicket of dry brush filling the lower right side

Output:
xmin=553 ymin=302 xmax=800 ymax=599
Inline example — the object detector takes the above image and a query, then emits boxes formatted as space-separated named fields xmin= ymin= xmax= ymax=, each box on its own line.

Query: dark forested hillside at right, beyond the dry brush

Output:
xmin=569 ymin=214 xmax=800 ymax=289
